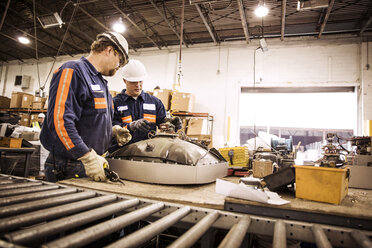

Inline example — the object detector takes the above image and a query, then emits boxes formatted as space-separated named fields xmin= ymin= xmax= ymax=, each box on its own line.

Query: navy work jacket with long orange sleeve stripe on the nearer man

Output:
xmin=40 ymin=57 xmax=114 ymax=159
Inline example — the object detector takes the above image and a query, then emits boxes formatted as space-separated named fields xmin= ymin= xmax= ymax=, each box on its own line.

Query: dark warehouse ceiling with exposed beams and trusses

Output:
xmin=0 ymin=0 xmax=372 ymax=62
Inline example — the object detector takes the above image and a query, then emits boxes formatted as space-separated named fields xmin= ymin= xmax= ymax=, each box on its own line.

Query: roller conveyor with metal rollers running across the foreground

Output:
xmin=0 ymin=174 xmax=372 ymax=248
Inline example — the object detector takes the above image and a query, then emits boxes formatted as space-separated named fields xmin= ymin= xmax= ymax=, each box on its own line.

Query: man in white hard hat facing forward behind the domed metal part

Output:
xmin=109 ymin=59 xmax=182 ymax=152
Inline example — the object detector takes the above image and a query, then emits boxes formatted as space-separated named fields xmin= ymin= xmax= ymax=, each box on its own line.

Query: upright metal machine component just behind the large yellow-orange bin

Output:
xmin=318 ymin=133 xmax=345 ymax=168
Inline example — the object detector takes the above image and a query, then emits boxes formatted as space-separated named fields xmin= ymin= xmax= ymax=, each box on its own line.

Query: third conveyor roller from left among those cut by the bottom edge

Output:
xmin=168 ymin=211 xmax=220 ymax=248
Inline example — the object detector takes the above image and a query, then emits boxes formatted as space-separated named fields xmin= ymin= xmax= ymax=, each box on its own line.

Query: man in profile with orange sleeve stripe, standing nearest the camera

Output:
xmin=40 ymin=32 xmax=130 ymax=182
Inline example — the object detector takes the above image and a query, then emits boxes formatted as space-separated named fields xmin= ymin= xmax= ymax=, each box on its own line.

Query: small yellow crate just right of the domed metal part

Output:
xmin=219 ymin=146 xmax=249 ymax=168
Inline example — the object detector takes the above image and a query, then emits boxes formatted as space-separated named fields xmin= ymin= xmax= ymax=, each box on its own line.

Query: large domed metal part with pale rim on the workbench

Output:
xmin=106 ymin=133 xmax=228 ymax=184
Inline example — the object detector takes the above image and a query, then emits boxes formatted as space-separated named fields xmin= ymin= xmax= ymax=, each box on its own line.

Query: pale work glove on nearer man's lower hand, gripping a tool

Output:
xmin=78 ymin=149 xmax=108 ymax=182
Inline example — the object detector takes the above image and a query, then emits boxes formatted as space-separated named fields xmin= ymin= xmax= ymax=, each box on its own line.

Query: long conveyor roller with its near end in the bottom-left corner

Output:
xmin=5 ymin=199 xmax=139 ymax=244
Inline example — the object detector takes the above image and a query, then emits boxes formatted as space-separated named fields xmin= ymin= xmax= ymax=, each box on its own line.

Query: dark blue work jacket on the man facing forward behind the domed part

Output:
xmin=110 ymin=89 xmax=166 ymax=152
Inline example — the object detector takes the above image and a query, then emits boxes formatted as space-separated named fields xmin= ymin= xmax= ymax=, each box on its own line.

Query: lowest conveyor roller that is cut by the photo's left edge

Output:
xmin=0 ymin=191 xmax=96 ymax=217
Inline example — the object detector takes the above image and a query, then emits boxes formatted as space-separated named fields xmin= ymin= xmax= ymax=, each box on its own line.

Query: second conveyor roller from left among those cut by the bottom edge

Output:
xmin=107 ymin=207 xmax=191 ymax=248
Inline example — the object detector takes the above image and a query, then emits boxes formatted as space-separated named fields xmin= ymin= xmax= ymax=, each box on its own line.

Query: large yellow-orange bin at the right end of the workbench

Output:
xmin=294 ymin=165 xmax=350 ymax=204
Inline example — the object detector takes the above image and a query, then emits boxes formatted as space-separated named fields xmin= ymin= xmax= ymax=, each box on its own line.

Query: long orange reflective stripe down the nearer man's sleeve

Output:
xmin=54 ymin=68 xmax=75 ymax=150
